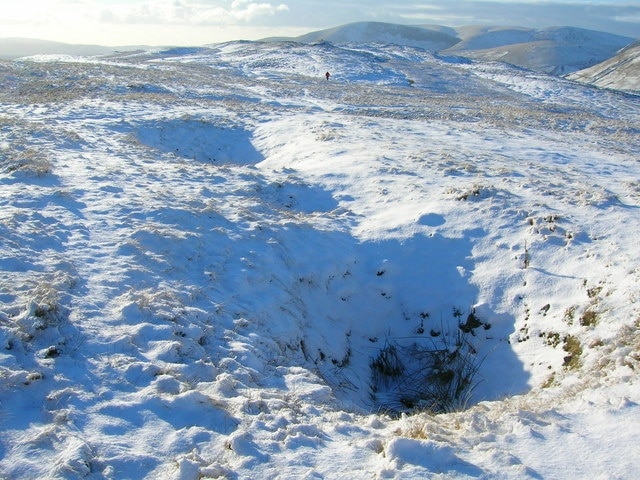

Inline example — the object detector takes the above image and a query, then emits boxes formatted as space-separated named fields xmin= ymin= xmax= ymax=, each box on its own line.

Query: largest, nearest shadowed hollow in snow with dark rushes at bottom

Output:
xmin=266 ymin=232 xmax=528 ymax=413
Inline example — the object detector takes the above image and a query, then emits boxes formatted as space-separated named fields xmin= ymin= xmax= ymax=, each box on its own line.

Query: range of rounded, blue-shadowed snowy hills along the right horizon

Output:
xmin=265 ymin=22 xmax=633 ymax=75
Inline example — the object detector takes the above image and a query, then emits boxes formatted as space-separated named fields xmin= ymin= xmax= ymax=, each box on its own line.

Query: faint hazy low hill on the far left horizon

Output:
xmin=0 ymin=38 xmax=139 ymax=60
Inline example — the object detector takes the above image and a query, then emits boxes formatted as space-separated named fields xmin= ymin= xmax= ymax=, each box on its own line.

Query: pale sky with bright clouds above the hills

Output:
xmin=0 ymin=0 xmax=640 ymax=46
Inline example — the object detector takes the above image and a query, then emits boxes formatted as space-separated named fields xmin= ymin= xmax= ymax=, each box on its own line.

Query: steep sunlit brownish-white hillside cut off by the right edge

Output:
xmin=568 ymin=41 xmax=640 ymax=94
